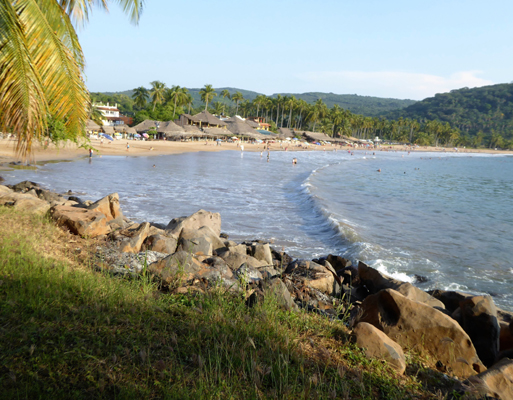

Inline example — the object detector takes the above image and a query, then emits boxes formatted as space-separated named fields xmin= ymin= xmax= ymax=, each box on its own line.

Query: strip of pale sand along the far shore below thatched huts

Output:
xmin=0 ymin=139 xmax=513 ymax=163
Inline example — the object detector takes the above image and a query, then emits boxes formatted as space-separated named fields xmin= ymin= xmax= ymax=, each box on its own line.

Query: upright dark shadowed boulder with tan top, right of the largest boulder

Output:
xmin=460 ymin=296 xmax=500 ymax=367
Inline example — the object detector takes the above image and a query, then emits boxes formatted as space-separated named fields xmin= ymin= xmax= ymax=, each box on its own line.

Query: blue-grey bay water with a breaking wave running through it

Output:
xmin=2 ymin=151 xmax=513 ymax=310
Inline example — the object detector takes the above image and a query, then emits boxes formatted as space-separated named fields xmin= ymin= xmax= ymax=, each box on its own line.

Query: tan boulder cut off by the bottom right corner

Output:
xmin=457 ymin=358 xmax=513 ymax=400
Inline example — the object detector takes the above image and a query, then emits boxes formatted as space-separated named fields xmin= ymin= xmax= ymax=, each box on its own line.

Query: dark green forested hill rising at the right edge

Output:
xmin=386 ymin=83 xmax=513 ymax=138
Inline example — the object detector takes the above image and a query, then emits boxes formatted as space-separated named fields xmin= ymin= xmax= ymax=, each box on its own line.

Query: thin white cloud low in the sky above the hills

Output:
xmin=296 ymin=71 xmax=493 ymax=100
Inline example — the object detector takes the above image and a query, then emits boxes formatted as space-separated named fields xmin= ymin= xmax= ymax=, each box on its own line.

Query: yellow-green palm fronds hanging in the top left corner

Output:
xmin=0 ymin=0 xmax=143 ymax=159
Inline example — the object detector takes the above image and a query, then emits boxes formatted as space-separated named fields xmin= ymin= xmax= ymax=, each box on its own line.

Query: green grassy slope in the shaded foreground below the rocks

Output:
xmin=0 ymin=208 xmax=456 ymax=399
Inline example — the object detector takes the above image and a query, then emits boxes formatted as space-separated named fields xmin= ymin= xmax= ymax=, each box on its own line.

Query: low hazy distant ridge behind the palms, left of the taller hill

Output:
xmin=97 ymin=87 xmax=416 ymax=117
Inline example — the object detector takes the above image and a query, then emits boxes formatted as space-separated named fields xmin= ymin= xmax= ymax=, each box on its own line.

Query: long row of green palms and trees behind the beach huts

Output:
xmin=93 ymin=81 xmax=513 ymax=148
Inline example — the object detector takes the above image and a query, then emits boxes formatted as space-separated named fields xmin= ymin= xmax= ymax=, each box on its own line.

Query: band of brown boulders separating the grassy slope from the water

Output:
xmin=0 ymin=181 xmax=513 ymax=399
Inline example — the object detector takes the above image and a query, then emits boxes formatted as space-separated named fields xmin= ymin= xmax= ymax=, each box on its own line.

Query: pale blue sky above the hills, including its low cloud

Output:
xmin=78 ymin=0 xmax=513 ymax=100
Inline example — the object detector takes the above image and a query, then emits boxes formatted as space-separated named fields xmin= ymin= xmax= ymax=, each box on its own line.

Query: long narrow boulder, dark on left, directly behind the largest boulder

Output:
xmin=358 ymin=261 xmax=445 ymax=309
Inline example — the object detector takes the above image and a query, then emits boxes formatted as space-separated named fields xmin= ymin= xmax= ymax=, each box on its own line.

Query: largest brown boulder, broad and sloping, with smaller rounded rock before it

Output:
xmin=358 ymin=289 xmax=486 ymax=378
